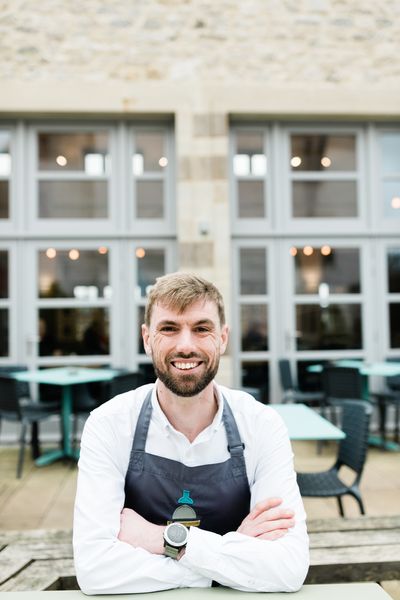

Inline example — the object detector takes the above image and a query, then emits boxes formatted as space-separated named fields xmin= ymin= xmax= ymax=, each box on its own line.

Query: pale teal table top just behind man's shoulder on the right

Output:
xmin=269 ymin=404 xmax=346 ymax=440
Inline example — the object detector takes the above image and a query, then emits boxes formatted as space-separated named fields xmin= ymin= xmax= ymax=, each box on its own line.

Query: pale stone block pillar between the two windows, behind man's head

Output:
xmin=175 ymin=106 xmax=232 ymax=385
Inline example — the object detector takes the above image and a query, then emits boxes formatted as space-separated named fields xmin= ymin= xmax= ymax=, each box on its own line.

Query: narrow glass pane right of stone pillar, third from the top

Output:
xmin=240 ymin=248 xmax=267 ymax=295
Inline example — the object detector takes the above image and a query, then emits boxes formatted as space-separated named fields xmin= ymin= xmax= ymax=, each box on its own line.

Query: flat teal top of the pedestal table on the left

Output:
xmin=13 ymin=367 xmax=118 ymax=385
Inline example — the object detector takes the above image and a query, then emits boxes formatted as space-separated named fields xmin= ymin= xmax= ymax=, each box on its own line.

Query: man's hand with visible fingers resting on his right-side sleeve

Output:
xmin=237 ymin=498 xmax=295 ymax=541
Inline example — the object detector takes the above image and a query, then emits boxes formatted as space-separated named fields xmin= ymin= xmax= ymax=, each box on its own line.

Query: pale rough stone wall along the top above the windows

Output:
xmin=0 ymin=0 xmax=400 ymax=87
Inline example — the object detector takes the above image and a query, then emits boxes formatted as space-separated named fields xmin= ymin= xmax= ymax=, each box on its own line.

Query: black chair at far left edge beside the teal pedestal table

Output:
xmin=0 ymin=373 xmax=60 ymax=478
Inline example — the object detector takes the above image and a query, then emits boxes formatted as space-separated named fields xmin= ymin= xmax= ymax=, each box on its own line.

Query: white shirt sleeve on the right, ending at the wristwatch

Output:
xmin=181 ymin=413 xmax=309 ymax=592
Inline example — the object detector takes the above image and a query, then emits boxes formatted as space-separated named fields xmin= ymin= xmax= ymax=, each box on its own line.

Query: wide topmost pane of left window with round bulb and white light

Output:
xmin=38 ymin=132 xmax=109 ymax=176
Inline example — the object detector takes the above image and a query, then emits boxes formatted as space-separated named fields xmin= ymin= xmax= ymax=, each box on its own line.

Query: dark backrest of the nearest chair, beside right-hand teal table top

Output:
xmin=338 ymin=400 xmax=372 ymax=478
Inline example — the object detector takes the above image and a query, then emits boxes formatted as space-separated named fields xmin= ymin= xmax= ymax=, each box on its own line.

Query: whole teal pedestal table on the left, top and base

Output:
xmin=12 ymin=367 xmax=118 ymax=466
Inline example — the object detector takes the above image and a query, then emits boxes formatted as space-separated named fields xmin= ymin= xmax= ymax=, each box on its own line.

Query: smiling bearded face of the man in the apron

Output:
xmin=142 ymin=300 xmax=228 ymax=397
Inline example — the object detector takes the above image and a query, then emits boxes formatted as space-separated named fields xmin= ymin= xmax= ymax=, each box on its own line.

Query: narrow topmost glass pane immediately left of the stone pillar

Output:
xmin=132 ymin=131 xmax=168 ymax=175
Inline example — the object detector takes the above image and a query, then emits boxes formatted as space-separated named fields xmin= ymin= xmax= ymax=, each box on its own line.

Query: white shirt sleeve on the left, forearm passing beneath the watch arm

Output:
xmin=73 ymin=416 xmax=211 ymax=594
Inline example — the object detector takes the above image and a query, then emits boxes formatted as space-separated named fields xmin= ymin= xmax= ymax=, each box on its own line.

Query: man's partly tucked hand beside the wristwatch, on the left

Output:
xmin=118 ymin=508 xmax=165 ymax=554
